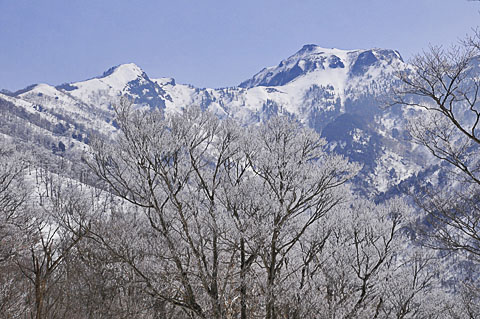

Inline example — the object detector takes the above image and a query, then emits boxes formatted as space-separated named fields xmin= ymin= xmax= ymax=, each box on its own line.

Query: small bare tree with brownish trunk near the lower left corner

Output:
xmin=15 ymin=177 xmax=94 ymax=319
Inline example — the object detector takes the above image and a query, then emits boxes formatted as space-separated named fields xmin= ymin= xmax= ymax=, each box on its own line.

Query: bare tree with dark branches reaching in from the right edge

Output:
xmin=394 ymin=33 xmax=480 ymax=316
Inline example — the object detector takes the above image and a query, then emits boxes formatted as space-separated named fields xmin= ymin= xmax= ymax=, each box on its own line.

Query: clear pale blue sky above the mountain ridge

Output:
xmin=0 ymin=0 xmax=480 ymax=90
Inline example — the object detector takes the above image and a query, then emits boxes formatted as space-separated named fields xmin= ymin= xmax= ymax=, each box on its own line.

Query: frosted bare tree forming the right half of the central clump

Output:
xmin=242 ymin=117 xmax=358 ymax=319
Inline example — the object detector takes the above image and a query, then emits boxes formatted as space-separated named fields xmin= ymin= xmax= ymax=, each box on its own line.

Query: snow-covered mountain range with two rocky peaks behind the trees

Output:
xmin=0 ymin=45 xmax=433 ymax=195
